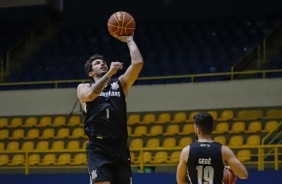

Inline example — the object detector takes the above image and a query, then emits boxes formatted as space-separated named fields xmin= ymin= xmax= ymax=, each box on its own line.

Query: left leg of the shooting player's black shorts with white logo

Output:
xmin=87 ymin=150 xmax=113 ymax=184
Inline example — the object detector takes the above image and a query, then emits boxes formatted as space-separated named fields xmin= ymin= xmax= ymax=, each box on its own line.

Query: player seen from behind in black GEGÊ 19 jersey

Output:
xmin=176 ymin=113 xmax=248 ymax=184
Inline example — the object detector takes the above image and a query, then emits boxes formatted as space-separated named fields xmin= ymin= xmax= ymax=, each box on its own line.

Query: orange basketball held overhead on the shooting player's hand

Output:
xmin=108 ymin=11 xmax=135 ymax=36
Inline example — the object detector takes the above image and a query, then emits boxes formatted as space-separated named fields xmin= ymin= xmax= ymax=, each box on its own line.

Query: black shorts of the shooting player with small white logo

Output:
xmin=87 ymin=149 xmax=132 ymax=184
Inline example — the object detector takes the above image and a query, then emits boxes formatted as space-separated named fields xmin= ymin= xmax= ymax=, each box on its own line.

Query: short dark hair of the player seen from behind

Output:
xmin=193 ymin=112 xmax=213 ymax=135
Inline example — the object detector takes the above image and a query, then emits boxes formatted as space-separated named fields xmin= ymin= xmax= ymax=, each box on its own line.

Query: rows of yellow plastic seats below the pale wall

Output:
xmin=0 ymin=108 xmax=282 ymax=172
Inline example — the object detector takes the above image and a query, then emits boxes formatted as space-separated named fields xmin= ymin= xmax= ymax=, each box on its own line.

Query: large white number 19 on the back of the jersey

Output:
xmin=196 ymin=166 xmax=214 ymax=184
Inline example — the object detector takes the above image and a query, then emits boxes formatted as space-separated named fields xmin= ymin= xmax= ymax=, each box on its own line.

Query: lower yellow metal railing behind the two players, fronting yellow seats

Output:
xmin=0 ymin=145 xmax=282 ymax=174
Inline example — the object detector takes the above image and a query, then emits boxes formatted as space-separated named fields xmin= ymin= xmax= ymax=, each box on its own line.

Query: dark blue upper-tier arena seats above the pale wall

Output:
xmin=1 ymin=19 xmax=281 ymax=89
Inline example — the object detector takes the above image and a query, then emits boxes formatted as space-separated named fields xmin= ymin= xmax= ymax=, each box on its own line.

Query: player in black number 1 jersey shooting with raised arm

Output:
xmin=77 ymin=36 xmax=143 ymax=184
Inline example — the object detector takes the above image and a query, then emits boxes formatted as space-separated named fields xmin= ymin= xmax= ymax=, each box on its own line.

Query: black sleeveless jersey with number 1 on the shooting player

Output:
xmin=84 ymin=79 xmax=129 ymax=157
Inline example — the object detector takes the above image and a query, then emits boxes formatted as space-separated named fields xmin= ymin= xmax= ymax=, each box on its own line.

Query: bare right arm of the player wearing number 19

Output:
xmin=222 ymin=146 xmax=248 ymax=179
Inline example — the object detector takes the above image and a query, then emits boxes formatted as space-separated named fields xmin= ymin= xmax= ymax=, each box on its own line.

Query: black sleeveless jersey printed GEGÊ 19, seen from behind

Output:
xmin=187 ymin=142 xmax=224 ymax=184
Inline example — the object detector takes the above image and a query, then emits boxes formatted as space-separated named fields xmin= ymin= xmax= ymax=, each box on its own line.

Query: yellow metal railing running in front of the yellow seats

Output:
xmin=0 ymin=145 xmax=282 ymax=174
